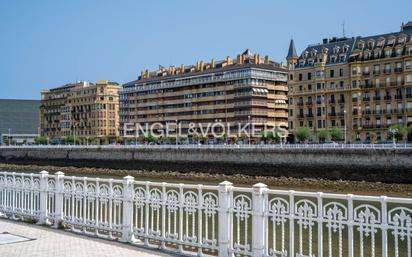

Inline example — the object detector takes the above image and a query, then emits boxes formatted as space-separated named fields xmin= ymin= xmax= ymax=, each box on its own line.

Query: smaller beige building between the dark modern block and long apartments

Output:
xmin=40 ymin=80 xmax=121 ymax=144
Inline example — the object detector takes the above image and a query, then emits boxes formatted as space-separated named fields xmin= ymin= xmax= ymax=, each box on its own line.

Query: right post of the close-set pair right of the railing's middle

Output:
xmin=252 ymin=183 xmax=267 ymax=257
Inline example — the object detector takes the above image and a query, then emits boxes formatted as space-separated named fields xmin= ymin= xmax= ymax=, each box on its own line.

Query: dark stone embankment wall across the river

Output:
xmin=0 ymin=148 xmax=412 ymax=183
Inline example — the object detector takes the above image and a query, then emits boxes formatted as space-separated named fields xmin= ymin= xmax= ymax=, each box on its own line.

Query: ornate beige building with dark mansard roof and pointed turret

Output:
xmin=287 ymin=22 xmax=412 ymax=142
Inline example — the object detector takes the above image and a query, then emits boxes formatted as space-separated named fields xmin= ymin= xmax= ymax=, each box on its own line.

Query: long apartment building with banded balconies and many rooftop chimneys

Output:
xmin=119 ymin=49 xmax=288 ymax=142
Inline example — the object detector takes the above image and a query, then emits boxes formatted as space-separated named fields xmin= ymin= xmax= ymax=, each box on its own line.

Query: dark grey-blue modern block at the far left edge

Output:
xmin=0 ymin=99 xmax=40 ymax=143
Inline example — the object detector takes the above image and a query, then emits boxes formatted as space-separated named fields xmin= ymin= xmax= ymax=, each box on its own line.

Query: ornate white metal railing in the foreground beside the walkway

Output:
xmin=0 ymin=171 xmax=412 ymax=257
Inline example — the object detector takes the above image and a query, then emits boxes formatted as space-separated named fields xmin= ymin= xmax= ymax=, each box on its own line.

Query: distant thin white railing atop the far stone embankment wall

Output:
xmin=0 ymin=143 xmax=412 ymax=149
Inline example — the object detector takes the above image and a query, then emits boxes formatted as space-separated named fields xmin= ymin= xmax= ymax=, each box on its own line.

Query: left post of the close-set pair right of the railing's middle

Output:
xmin=218 ymin=181 xmax=233 ymax=257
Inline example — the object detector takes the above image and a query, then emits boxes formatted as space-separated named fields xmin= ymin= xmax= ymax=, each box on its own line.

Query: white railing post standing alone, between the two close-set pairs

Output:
xmin=120 ymin=176 xmax=134 ymax=242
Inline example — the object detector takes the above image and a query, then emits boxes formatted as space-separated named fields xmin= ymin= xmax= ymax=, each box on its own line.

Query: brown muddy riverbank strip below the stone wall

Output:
xmin=0 ymin=163 xmax=412 ymax=197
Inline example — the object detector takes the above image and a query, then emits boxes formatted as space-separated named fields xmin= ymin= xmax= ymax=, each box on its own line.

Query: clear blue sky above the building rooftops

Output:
xmin=0 ymin=0 xmax=412 ymax=99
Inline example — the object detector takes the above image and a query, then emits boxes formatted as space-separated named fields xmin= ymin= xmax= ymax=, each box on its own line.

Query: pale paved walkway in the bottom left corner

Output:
xmin=0 ymin=219 xmax=170 ymax=257
